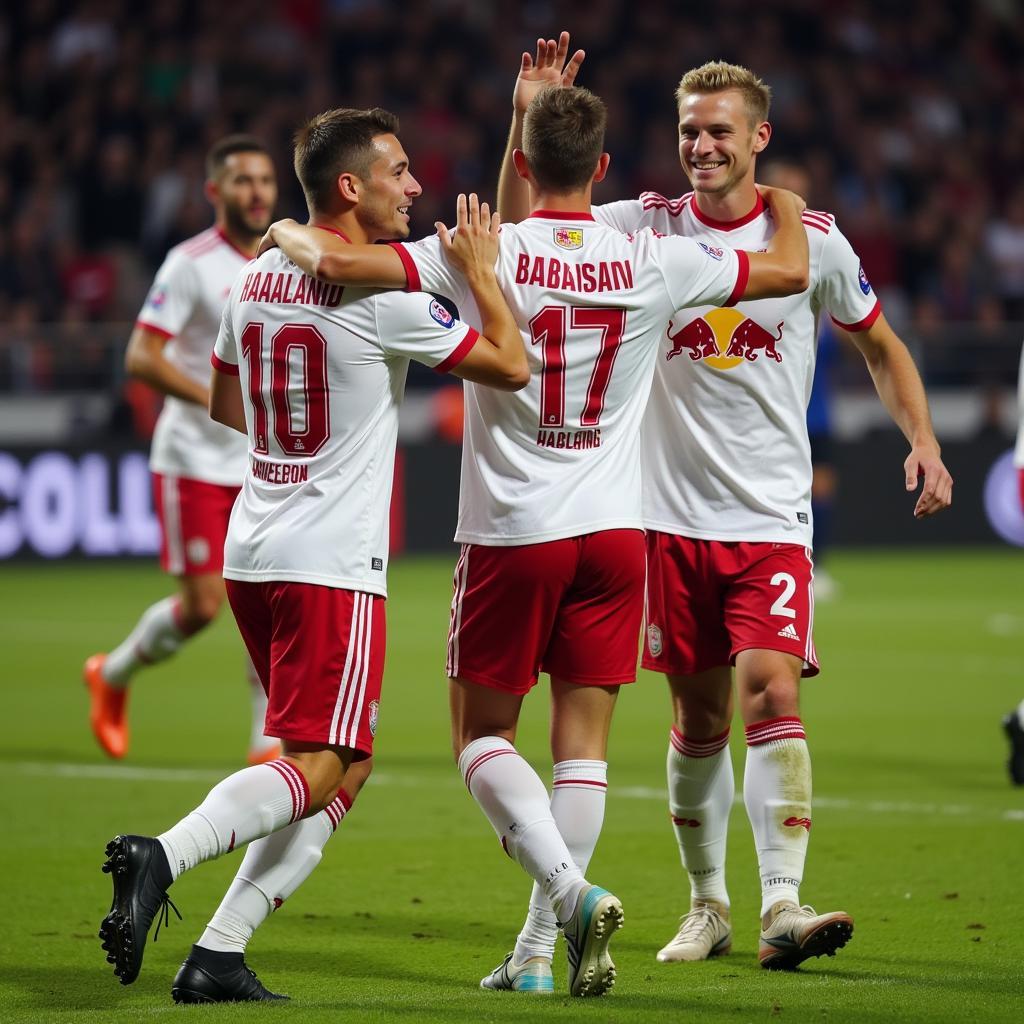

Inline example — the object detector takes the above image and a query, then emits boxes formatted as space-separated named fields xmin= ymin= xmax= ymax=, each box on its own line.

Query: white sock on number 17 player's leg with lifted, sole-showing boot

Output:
xmin=459 ymin=736 xmax=587 ymax=921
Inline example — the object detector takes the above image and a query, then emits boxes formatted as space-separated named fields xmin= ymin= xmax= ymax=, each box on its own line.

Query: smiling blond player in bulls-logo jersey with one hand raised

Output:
xmin=499 ymin=33 xmax=952 ymax=968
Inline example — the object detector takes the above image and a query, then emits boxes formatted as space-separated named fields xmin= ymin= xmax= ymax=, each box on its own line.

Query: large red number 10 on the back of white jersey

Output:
xmin=242 ymin=324 xmax=331 ymax=459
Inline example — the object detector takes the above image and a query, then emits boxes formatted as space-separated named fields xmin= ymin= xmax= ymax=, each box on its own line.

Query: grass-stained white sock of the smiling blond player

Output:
xmin=743 ymin=716 xmax=811 ymax=916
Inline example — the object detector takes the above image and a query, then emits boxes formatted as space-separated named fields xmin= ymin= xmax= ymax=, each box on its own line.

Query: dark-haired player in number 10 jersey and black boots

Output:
xmin=100 ymin=110 xmax=529 ymax=1002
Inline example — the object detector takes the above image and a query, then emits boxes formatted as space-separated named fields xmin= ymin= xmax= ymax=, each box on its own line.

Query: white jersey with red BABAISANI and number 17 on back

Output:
xmin=394 ymin=211 xmax=749 ymax=545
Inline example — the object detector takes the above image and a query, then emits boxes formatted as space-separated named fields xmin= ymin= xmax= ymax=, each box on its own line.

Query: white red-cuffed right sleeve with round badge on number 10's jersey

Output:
xmin=376 ymin=292 xmax=480 ymax=374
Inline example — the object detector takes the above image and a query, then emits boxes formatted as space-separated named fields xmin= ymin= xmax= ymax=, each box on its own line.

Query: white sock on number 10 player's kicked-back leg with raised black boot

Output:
xmin=157 ymin=760 xmax=309 ymax=879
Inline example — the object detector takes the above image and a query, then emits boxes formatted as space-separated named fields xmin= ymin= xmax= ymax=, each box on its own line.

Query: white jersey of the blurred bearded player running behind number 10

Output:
xmin=135 ymin=227 xmax=249 ymax=486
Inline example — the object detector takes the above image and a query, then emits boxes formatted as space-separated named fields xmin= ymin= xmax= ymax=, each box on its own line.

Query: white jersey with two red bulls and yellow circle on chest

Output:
xmin=594 ymin=193 xmax=881 ymax=547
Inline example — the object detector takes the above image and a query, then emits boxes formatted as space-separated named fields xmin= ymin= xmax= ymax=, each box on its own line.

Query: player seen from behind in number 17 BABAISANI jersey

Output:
xmin=260 ymin=83 xmax=806 ymax=995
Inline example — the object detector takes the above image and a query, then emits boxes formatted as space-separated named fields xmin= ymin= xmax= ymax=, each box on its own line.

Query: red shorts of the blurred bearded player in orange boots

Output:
xmin=153 ymin=473 xmax=242 ymax=575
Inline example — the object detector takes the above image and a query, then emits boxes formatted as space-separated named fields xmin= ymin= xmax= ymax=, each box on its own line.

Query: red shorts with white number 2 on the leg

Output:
xmin=643 ymin=530 xmax=818 ymax=676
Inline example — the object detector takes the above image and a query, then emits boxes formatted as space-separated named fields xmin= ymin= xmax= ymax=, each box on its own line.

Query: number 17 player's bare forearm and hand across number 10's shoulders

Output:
xmin=256 ymin=220 xmax=406 ymax=288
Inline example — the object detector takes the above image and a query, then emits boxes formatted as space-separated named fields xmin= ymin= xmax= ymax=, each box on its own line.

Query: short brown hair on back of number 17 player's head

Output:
xmin=522 ymin=86 xmax=608 ymax=193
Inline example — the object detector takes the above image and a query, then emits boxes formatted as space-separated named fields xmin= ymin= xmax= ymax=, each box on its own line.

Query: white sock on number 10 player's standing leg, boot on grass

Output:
xmin=196 ymin=790 xmax=352 ymax=953
